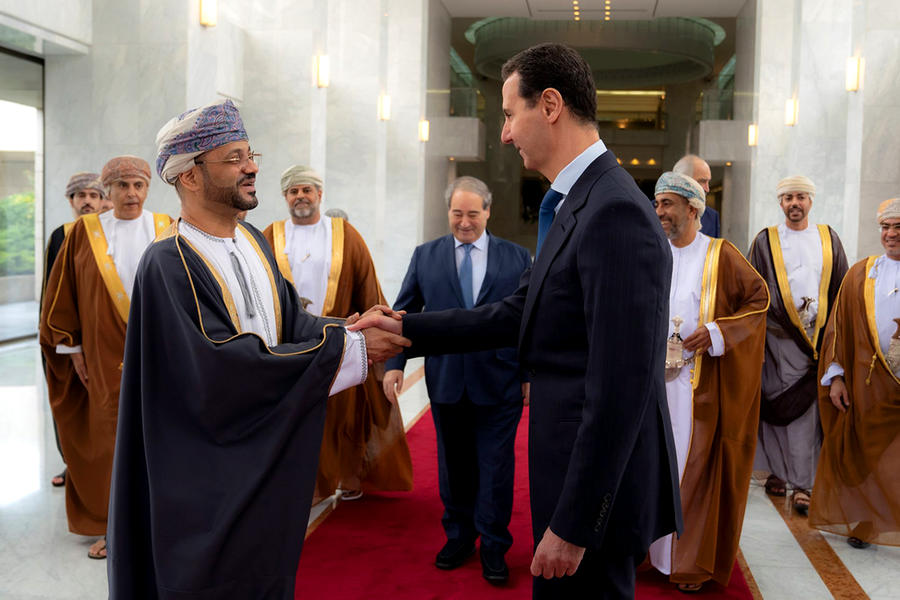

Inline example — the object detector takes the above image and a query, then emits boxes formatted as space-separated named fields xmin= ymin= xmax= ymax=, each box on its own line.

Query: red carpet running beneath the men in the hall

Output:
xmin=295 ymin=408 xmax=752 ymax=600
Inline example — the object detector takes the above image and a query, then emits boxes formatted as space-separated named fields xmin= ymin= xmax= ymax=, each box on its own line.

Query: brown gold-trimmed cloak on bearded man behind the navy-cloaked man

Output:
xmin=263 ymin=217 xmax=412 ymax=497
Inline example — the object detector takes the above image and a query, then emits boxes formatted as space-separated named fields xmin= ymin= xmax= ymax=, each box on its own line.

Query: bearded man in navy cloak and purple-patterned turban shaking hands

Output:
xmin=107 ymin=100 xmax=408 ymax=600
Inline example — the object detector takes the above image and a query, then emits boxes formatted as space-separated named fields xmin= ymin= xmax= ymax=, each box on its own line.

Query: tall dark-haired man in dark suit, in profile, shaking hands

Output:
xmin=357 ymin=44 xmax=681 ymax=599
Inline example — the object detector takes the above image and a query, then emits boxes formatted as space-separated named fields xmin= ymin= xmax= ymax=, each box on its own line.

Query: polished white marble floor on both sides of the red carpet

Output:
xmin=0 ymin=340 xmax=900 ymax=600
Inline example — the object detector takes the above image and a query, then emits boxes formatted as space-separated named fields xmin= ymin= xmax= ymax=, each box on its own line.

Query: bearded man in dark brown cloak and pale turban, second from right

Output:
xmin=749 ymin=175 xmax=847 ymax=515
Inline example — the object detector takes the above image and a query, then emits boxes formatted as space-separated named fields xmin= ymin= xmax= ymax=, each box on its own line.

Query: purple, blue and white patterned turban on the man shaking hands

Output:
xmin=156 ymin=100 xmax=248 ymax=183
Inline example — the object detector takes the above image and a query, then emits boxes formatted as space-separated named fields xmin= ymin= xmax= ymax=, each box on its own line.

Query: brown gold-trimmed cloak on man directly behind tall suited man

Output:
xmin=670 ymin=239 xmax=769 ymax=585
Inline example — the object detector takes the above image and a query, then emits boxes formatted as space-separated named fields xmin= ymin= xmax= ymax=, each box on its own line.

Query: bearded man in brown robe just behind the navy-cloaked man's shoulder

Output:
xmin=263 ymin=165 xmax=412 ymax=502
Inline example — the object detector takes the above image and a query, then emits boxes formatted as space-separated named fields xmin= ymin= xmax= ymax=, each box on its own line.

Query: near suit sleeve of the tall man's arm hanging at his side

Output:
xmin=550 ymin=199 xmax=672 ymax=547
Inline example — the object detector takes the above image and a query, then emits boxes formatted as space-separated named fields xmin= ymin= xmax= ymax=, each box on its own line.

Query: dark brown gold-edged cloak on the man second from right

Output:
xmin=748 ymin=225 xmax=847 ymax=426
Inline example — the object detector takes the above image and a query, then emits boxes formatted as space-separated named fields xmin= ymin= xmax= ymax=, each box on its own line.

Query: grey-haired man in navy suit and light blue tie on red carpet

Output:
xmin=384 ymin=177 xmax=531 ymax=584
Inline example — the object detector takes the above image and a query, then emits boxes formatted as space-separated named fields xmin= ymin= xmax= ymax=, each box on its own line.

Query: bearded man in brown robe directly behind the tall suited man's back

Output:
xmin=650 ymin=172 xmax=769 ymax=592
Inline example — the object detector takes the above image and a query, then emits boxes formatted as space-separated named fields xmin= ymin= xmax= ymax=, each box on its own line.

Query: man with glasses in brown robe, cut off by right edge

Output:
xmin=809 ymin=198 xmax=900 ymax=548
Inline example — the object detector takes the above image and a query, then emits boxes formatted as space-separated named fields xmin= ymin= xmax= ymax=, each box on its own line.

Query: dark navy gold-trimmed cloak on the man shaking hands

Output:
xmin=107 ymin=223 xmax=345 ymax=600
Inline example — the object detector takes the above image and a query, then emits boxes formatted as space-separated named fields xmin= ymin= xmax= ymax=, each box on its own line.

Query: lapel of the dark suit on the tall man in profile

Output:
xmin=519 ymin=150 xmax=618 ymax=344
